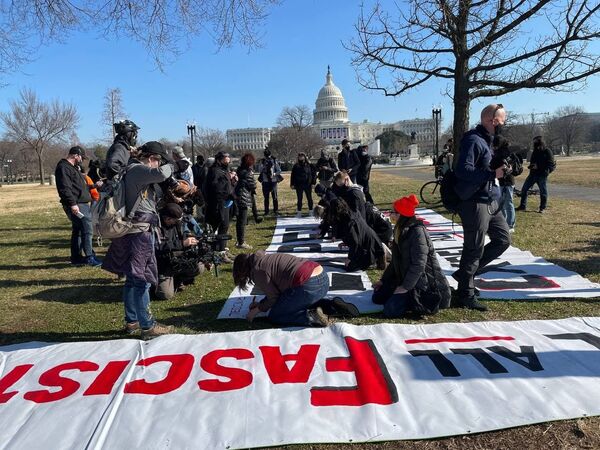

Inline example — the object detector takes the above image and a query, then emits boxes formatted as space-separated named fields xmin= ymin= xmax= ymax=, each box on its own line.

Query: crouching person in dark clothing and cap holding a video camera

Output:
xmin=155 ymin=203 xmax=205 ymax=300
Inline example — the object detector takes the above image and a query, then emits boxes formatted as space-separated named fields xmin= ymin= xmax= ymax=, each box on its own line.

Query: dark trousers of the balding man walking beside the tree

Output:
xmin=453 ymin=200 xmax=510 ymax=298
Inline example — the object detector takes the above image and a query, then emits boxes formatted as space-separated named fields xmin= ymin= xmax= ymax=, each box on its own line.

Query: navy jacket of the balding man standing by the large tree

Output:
xmin=454 ymin=125 xmax=500 ymax=202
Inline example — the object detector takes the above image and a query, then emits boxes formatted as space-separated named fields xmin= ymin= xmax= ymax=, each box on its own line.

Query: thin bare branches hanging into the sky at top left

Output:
xmin=0 ymin=0 xmax=280 ymax=81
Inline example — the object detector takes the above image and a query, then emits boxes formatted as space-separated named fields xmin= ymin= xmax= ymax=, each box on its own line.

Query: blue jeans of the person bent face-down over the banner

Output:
xmin=269 ymin=271 xmax=329 ymax=326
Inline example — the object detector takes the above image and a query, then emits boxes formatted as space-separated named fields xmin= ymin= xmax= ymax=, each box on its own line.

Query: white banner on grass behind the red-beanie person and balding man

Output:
xmin=417 ymin=209 xmax=600 ymax=300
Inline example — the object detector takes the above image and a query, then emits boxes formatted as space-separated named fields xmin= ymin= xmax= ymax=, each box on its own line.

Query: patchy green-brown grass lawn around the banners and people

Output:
xmin=0 ymin=171 xmax=600 ymax=448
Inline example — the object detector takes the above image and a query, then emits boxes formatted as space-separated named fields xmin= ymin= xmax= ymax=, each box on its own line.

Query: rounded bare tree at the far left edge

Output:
xmin=0 ymin=89 xmax=79 ymax=184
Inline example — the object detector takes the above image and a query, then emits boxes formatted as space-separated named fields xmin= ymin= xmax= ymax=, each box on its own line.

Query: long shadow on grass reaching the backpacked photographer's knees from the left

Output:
xmin=23 ymin=280 xmax=123 ymax=305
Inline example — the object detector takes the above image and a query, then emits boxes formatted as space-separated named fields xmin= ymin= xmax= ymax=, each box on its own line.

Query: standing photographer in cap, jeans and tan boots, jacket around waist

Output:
xmin=102 ymin=141 xmax=173 ymax=339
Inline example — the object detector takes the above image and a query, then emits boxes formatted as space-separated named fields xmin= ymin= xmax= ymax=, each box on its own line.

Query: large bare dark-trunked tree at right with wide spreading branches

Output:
xmin=346 ymin=0 xmax=600 ymax=154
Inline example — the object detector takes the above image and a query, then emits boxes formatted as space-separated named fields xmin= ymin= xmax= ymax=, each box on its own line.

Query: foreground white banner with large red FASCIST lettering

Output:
xmin=0 ymin=317 xmax=600 ymax=450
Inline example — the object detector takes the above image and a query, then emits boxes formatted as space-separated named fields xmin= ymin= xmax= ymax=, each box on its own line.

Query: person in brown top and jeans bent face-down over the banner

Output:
xmin=233 ymin=250 xmax=329 ymax=327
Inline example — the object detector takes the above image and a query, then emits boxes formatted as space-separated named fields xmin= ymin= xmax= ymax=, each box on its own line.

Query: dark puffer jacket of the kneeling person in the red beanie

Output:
xmin=381 ymin=217 xmax=450 ymax=314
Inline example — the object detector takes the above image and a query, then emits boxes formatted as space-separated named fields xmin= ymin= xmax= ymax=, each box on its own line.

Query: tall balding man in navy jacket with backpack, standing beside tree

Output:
xmin=452 ymin=104 xmax=510 ymax=311
